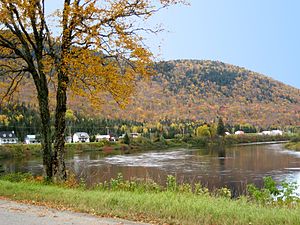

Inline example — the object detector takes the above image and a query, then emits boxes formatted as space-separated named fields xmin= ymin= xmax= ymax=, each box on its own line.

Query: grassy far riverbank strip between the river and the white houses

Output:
xmin=0 ymin=134 xmax=291 ymax=158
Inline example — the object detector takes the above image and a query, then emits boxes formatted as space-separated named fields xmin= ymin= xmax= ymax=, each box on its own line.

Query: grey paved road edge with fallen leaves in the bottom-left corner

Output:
xmin=0 ymin=199 xmax=146 ymax=225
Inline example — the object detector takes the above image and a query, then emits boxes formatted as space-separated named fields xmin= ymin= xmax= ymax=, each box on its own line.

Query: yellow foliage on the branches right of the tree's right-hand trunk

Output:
xmin=43 ymin=0 xmax=179 ymax=110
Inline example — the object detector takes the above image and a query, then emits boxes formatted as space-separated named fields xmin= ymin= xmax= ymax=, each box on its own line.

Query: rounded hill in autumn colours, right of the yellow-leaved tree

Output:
xmin=88 ymin=60 xmax=300 ymax=126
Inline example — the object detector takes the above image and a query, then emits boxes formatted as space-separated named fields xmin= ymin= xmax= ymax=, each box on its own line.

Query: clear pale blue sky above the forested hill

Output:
xmin=50 ymin=0 xmax=300 ymax=88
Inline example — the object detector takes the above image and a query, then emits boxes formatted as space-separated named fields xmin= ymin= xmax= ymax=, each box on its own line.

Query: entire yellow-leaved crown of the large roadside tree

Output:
xmin=0 ymin=0 xmax=181 ymax=118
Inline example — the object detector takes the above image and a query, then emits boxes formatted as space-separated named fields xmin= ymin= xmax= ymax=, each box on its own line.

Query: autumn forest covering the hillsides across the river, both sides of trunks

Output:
xmin=0 ymin=60 xmax=300 ymax=138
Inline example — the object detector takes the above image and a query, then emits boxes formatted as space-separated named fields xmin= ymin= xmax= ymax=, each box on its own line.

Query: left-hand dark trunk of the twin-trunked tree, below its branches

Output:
xmin=37 ymin=80 xmax=53 ymax=180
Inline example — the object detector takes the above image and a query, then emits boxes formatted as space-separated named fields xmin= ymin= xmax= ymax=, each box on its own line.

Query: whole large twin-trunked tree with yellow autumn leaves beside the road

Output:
xmin=0 ymin=0 xmax=181 ymax=180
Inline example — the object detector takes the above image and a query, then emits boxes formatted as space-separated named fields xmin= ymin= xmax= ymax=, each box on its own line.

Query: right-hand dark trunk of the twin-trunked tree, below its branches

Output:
xmin=53 ymin=72 xmax=68 ymax=182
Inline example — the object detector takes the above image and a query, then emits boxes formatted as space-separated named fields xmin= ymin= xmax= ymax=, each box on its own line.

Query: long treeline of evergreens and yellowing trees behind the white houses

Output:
xmin=0 ymin=103 xmax=299 ymax=141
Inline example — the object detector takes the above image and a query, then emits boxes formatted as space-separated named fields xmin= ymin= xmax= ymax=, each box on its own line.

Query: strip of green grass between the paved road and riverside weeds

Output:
xmin=0 ymin=180 xmax=300 ymax=225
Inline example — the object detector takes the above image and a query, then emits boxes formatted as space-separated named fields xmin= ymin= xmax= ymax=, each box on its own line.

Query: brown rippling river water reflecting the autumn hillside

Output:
xmin=0 ymin=144 xmax=300 ymax=195
